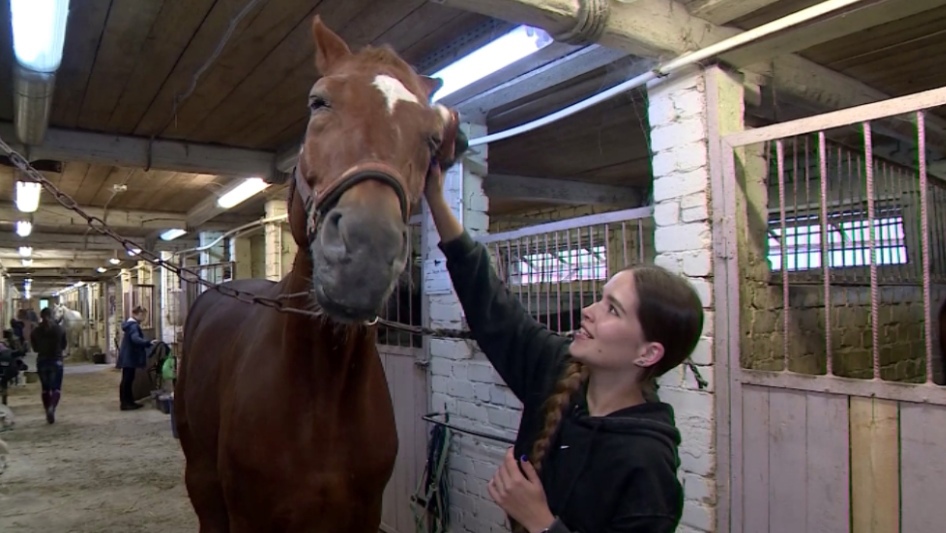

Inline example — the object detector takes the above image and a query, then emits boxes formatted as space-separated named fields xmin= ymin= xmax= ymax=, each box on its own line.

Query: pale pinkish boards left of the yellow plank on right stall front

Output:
xmin=734 ymin=386 xmax=850 ymax=533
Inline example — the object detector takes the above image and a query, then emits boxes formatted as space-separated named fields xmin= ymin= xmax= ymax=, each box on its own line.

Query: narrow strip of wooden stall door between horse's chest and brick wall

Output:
xmin=378 ymin=345 xmax=429 ymax=533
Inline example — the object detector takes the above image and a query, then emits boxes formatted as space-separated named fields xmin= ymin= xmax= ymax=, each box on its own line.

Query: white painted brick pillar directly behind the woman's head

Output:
xmin=648 ymin=63 xmax=744 ymax=532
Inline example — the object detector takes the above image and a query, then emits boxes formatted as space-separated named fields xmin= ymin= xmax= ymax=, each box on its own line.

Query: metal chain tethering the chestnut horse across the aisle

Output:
xmin=0 ymin=137 xmax=709 ymax=389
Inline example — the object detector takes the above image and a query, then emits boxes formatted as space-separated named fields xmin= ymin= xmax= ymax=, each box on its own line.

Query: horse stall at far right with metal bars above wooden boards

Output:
xmin=714 ymin=88 xmax=946 ymax=533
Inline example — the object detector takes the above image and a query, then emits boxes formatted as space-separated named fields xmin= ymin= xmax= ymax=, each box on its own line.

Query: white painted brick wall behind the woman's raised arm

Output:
xmin=423 ymin=125 xmax=522 ymax=533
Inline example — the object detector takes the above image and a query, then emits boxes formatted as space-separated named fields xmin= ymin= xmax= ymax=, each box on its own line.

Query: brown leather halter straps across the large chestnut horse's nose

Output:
xmin=292 ymin=161 xmax=410 ymax=244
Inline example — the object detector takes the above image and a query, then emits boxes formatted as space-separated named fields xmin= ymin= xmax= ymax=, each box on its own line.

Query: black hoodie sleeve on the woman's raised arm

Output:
xmin=438 ymin=231 xmax=570 ymax=403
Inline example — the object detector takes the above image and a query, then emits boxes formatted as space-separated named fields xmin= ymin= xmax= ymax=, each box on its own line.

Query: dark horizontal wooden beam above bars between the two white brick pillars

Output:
xmin=483 ymin=174 xmax=645 ymax=207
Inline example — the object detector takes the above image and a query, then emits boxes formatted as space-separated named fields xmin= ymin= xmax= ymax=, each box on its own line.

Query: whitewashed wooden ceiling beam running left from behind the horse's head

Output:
xmin=0 ymin=122 xmax=275 ymax=179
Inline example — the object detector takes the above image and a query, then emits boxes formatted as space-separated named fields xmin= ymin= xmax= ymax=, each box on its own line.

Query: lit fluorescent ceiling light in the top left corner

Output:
xmin=10 ymin=0 xmax=69 ymax=72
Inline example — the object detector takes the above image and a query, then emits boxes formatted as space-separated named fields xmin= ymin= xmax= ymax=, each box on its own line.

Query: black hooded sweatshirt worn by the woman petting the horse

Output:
xmin=439 ymin=232 xmax=683 ymax=533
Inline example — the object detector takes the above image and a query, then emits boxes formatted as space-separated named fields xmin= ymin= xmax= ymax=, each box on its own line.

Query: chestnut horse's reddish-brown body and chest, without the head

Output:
xmin=175 ymin=272 xmax=397 ymax=533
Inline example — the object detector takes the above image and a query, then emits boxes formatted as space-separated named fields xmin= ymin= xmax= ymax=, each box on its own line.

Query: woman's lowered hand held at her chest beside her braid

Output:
xmin=486 ymin=448 xmax=555 ymax=532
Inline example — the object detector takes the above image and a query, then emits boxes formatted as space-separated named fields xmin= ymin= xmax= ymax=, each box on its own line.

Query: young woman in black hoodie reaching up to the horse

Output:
xmin=426 ymin=176 xmax=703 ymax=533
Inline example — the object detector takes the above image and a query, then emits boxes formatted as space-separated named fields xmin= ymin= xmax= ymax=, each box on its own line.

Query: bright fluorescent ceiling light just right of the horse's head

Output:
xmin=431 ymin=26 xmax=552 ymax=102
